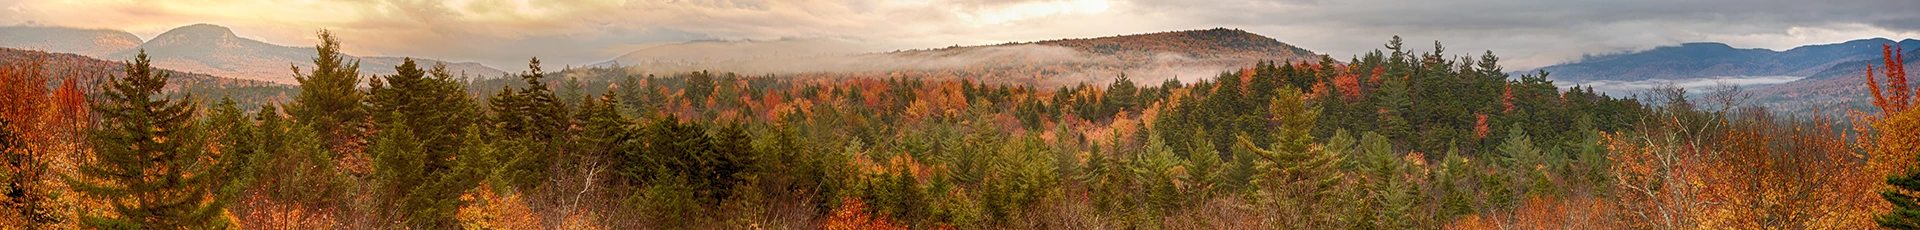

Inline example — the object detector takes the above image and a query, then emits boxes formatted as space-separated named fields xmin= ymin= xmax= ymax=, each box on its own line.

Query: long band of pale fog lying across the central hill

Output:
xmin=603 ymin=44 xmax=1252 ymax=86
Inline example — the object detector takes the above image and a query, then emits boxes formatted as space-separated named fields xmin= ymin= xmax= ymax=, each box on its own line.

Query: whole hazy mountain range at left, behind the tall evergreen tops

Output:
xmin=0 ymin=23 xmax=505 ymax=84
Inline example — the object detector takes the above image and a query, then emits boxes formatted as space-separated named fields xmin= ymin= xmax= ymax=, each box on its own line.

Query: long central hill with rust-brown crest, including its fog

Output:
xmin=601 ymin=29 xmax=1321 ymax=84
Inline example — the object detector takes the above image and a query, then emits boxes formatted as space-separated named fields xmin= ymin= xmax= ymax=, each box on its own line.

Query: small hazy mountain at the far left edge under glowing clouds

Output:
xmin=0 ymin=25 xmax=140 ymax=58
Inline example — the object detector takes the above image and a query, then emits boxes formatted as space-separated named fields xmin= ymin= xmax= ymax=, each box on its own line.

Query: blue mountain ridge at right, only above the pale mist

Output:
xmin=1540 ymin=38 xmax=1920 ymax=82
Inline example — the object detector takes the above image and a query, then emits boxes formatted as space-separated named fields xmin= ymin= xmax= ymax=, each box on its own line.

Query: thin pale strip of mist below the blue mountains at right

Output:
xmin=1553 ymin=77 xmax=1807 ymax=96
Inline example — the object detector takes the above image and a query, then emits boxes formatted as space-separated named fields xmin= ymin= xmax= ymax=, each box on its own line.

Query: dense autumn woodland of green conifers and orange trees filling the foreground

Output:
xmin=0 ymin=33 xmax=1920 ymax=230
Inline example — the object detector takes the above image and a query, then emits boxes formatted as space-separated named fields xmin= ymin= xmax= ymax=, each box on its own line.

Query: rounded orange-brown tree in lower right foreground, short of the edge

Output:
xmin=1701 ymin=107 xmax=1874 ymax=228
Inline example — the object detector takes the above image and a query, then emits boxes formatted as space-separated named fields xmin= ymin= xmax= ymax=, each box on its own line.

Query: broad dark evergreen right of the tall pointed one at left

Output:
xmin=367 ymin=58 xmax=486 ymax=228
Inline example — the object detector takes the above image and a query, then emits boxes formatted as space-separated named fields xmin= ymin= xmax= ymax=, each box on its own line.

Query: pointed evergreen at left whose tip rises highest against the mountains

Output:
xmin=286 ymin=31 xmax=367 ymax=166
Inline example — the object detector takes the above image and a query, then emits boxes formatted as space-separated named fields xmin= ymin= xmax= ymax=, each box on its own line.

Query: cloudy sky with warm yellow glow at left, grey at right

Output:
xmin=0 ymin=0 xmax=1920 ymax=71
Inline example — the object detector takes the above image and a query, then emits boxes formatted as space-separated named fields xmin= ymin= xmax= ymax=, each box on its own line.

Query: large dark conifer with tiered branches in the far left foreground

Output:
xmin=67 ymin=50 xmax=228 ymax=228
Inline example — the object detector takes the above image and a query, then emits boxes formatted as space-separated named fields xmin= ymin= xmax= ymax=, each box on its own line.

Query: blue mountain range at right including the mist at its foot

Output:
xmin=1540 ymin=38 xmax=1920 ymax=117
